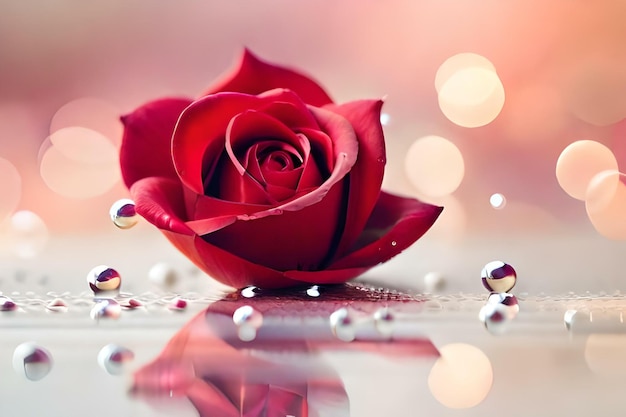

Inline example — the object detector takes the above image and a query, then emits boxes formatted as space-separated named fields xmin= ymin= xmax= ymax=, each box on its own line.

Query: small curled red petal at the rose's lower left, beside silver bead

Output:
xmin=130 ymin=177 xmax=194 ymax=235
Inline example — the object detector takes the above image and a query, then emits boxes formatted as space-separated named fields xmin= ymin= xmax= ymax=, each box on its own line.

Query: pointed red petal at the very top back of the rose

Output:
xmin=202 ymin=49 xmax=332 ymax=106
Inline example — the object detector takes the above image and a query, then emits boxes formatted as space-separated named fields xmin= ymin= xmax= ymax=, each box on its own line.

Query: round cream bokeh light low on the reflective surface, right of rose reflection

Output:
xmin=428 ymin=343 xmax=493 ymax=409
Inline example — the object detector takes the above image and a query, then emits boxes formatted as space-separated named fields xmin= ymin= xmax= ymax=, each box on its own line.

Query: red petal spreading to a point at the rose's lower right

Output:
xmin=285 ymin=192 xmax=443 ymax=284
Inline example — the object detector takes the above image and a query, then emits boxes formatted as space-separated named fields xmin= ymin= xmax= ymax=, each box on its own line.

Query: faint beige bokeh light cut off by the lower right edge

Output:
xmin=585 ymin=332 xmax=626 ymax=378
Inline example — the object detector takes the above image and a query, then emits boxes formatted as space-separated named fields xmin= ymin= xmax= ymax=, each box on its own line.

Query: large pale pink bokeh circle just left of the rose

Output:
xmin=39 ymin=126 xmax=120 ymax=199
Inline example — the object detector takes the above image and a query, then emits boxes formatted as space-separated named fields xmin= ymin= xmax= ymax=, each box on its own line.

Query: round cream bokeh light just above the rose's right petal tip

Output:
xmin=404 ymin=135 xmax=465 ymax=197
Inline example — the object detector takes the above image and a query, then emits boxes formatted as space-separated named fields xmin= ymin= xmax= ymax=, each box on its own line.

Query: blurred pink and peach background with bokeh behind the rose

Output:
xmin=0 ymin=0 xmax=626 ymax=293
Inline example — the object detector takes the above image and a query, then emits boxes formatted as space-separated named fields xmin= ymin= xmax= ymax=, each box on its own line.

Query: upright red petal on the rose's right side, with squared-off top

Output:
xmin=325 ymin=100 xmax=385 ymax=257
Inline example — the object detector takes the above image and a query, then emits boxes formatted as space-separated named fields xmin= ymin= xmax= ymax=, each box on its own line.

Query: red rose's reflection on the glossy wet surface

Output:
xmin=132 ymin=285 xmax=438 ymax=417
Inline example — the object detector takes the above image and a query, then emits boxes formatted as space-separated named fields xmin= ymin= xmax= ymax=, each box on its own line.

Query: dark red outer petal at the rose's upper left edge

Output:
xmin=120 ymin=98 xmax=191 ymax=188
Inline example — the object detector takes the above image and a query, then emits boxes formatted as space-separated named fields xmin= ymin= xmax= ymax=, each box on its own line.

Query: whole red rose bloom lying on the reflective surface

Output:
xmin=120 ymin=50 xmax=442 ymax=288
